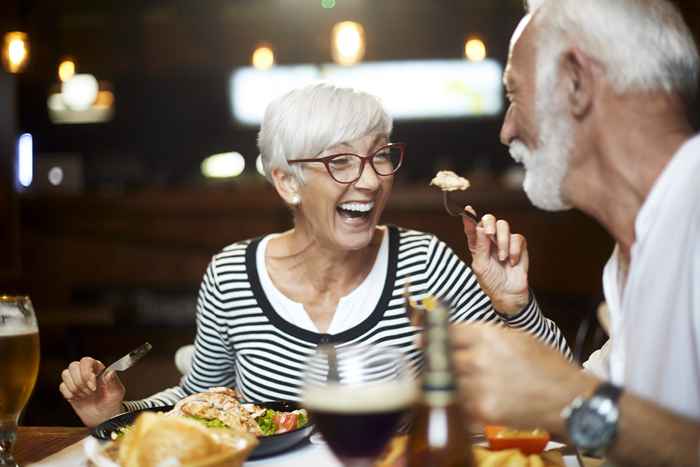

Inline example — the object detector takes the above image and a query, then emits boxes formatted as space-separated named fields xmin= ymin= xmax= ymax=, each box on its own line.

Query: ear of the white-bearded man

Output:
xmin=560 ymin=47 xmax=597 ymax=119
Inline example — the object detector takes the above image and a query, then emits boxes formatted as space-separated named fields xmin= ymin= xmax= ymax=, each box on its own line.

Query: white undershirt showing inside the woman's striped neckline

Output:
xmin=255 ymin=232 xmax=389 ymax=334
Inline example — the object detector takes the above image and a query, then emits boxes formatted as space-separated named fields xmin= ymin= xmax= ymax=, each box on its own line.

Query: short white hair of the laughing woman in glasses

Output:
xmin=258 ymin=82 xmax=393 ymax=182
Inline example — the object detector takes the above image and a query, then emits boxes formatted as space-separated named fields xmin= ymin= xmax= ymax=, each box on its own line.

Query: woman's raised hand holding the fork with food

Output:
xmin=462 ymin=210 xmax=530 ymax=316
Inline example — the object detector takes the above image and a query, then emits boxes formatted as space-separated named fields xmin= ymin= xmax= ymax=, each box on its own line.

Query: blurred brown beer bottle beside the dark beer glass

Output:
xmin=407 ymin=298 xmax=475 ymax=467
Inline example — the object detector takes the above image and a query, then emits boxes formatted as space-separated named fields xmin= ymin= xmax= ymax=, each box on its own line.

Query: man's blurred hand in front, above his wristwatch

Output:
xmin=452 ymin=324 xmax=597 ymax=436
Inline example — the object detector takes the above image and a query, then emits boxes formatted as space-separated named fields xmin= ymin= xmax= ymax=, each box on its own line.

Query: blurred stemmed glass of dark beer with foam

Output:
xmin=302 ymin=345 xmax=418 ymax=467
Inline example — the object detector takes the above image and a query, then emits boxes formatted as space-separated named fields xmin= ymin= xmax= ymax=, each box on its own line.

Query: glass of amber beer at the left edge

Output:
xmin=0 ymin=295 xmax=39 ymax=467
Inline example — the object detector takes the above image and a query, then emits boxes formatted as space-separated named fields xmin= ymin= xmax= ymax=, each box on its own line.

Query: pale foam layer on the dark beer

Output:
xmin=302 ymin=381 xmax=418 ymax=414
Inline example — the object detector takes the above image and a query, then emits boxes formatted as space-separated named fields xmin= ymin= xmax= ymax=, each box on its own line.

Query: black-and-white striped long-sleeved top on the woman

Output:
xmin=124 ymin=226 xmax=571 ymax=410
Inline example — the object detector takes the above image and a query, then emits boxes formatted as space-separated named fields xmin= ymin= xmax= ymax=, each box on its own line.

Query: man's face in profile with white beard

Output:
xmin=501 ymin=16 xmax=572 ymax=211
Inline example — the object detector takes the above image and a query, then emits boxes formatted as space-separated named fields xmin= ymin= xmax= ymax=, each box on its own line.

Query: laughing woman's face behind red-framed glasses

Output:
xmin=297 ymin=134 xmax=394 ymax=250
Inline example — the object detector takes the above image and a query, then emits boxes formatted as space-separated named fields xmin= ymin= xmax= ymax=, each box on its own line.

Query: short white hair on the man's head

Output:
xmin=526 ymin=0 xmax=698 ymax=100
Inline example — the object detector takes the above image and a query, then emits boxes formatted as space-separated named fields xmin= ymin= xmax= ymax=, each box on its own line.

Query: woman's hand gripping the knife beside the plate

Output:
xmin=58 ymin=357 xmax=126 ymax=427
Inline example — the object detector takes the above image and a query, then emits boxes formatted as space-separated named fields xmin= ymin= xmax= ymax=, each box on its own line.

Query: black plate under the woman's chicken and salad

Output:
xmin=90 ymin=401 xmax=314 ymax=459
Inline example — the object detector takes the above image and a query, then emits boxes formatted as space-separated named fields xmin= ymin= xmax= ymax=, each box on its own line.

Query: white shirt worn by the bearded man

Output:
xmin=587 ymin=136 xmax=700 ymax=420
